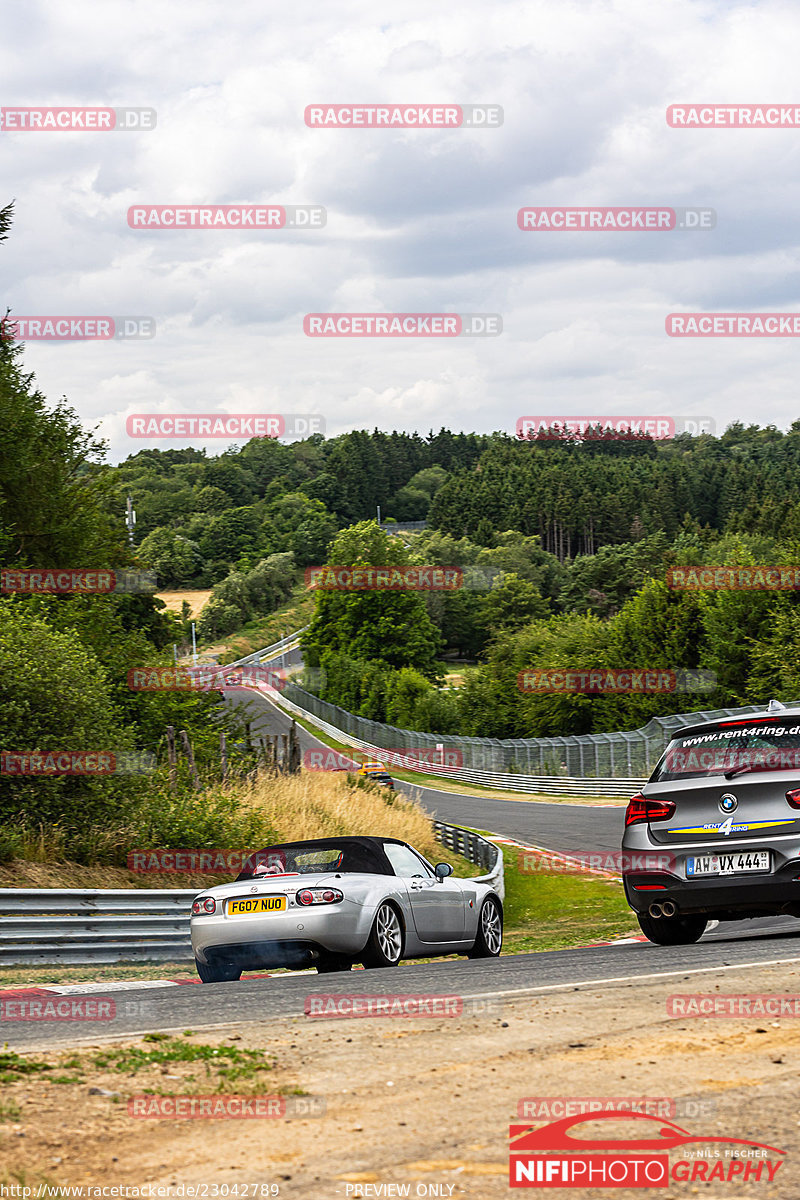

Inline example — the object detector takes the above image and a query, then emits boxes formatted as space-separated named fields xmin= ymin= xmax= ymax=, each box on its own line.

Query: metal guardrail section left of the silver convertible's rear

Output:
xmin=0 ymin=888 xmax=200 ymax=966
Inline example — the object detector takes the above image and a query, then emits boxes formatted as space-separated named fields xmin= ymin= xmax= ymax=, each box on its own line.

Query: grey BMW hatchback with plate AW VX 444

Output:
xmin=622 ymin=701 xmax=800 ymax=946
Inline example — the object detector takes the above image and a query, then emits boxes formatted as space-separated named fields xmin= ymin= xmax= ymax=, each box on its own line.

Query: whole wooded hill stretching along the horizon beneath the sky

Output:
xmin=109 ymin=421 xmax=800 ymax=587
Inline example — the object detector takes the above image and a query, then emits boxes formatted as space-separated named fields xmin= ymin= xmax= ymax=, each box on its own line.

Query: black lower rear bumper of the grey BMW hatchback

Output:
xmin=622 ymin=862 xmax=800 ymax=920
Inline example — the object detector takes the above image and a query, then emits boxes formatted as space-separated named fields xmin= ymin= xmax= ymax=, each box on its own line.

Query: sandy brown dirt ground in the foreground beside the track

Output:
xmin=0 ymin=960 xmax=800 ymax=1200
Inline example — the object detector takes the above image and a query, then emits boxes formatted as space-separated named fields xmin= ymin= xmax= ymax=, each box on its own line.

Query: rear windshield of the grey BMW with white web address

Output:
xmin=650 ymin=718 xmax=800 ymax=784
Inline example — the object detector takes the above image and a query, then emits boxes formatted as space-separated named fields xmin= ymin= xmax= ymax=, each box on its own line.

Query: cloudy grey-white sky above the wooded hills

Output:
xmin=0 ymin=0 xmax=800 ymax=461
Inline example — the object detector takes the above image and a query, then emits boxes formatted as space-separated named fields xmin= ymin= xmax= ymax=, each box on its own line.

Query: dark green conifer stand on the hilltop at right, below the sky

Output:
xmin=428 ymin=421 xmax=800 ymax=562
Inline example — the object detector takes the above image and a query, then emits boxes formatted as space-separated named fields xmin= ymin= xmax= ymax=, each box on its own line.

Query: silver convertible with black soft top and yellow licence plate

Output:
xmin=192 ymin=838 xmax=503 ymax=983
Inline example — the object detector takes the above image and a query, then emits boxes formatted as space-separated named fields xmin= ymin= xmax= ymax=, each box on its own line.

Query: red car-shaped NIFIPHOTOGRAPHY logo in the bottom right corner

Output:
xmin=509 ymin=1109 xmax=786 ymax=1188
